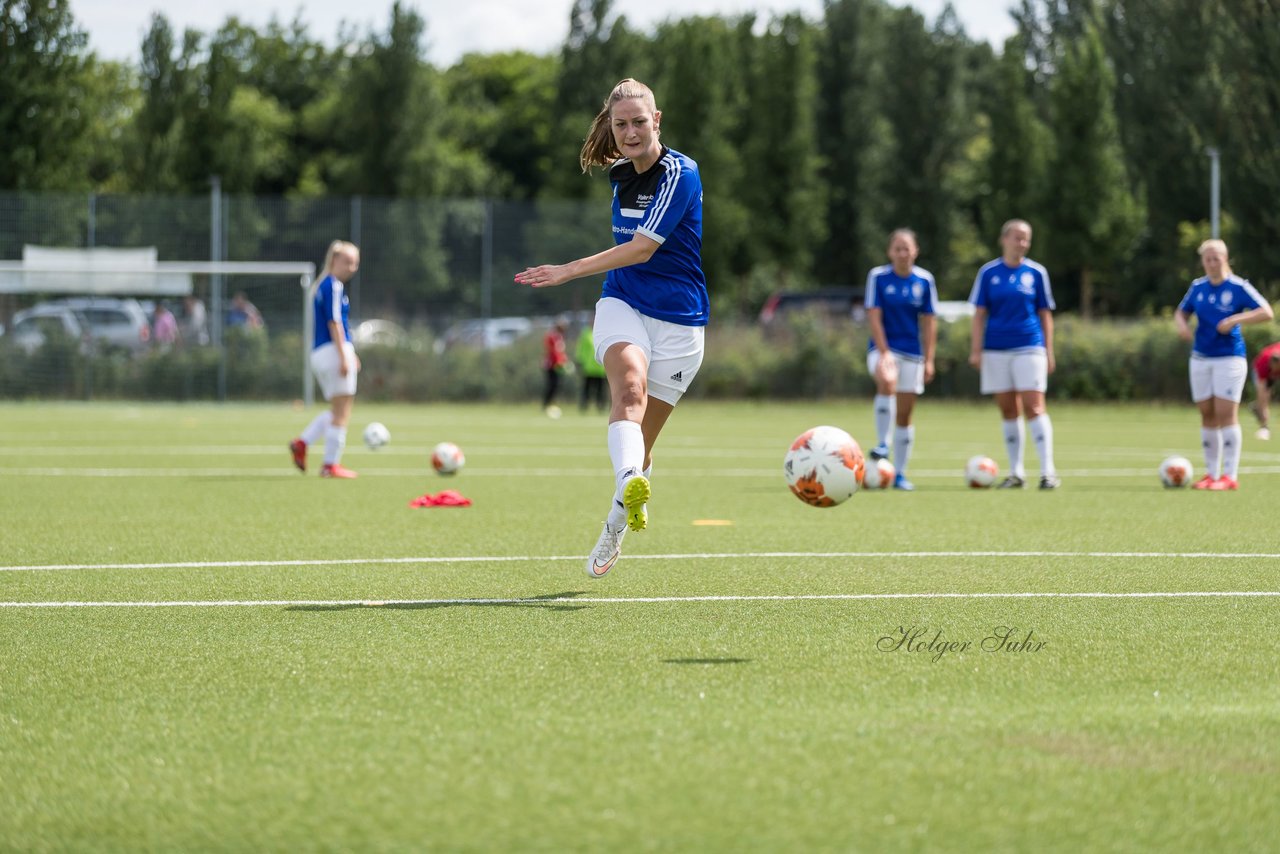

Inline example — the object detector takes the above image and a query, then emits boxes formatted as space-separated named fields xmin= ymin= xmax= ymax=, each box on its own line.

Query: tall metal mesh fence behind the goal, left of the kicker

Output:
xmin=0 ymin=188 xmax=612 ymax=329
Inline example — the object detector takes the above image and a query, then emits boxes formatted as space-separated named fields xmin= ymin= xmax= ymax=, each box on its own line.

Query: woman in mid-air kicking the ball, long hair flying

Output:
xmin=516 ymin=78 xmax=709 ymax=577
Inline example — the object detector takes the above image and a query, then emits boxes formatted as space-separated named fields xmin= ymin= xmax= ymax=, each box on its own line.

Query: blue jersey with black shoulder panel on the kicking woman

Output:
xmin=602 ymin=146 xmax=710 ymax=326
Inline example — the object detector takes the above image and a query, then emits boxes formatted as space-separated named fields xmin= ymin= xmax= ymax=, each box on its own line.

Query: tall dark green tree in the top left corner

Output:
xmin=0 ymin=0 xmax=91 ymax=189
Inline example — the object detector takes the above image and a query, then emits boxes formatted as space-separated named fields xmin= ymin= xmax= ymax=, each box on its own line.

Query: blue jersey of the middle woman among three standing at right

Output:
xmin=969 ymin=257 xmax=1057 ymax=350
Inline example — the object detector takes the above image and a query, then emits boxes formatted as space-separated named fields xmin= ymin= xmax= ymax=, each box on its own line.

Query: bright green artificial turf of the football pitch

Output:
xmin=0 ymin=398 xmax=1280 ymax=851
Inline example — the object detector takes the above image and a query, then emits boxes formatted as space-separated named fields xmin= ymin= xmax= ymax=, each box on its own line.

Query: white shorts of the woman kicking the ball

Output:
xmin=594 ymin=297 xmax=705 ymax=406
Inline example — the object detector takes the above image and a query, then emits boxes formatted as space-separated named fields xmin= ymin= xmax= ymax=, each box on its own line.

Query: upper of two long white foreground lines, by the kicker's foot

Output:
xmin=0 ymin=551 xmax=1280 ymax=572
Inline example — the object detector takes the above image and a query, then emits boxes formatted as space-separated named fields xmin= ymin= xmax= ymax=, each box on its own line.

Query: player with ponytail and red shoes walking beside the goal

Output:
xmin=289 ymin=241 xmax=360 ymax=478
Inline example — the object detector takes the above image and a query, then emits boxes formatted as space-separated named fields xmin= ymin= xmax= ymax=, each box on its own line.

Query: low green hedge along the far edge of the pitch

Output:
xmin=0 ymin=316 xmax=1280 ymax=402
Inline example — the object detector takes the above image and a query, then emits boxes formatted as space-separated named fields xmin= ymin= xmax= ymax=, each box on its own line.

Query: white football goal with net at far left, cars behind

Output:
xmin=0 ymin=247 xmax=316 ymax=403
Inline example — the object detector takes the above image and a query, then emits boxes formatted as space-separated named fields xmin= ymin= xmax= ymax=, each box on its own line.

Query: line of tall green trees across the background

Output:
xmin=0 ymin=0 xmax=1280 ymax=316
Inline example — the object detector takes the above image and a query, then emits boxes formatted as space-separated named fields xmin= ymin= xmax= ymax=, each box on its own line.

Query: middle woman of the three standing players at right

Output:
xmin=969 ymin=219 xmax=1062 ymax=489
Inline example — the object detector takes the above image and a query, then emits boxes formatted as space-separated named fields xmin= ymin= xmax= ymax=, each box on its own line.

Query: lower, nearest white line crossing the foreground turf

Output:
xmin=0 ymin=590 xmax=1280 ymax=608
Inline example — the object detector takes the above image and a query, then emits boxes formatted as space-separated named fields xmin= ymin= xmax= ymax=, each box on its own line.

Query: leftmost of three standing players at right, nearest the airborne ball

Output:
xmin=864 ymin=228 xmax=938 ymax=490
